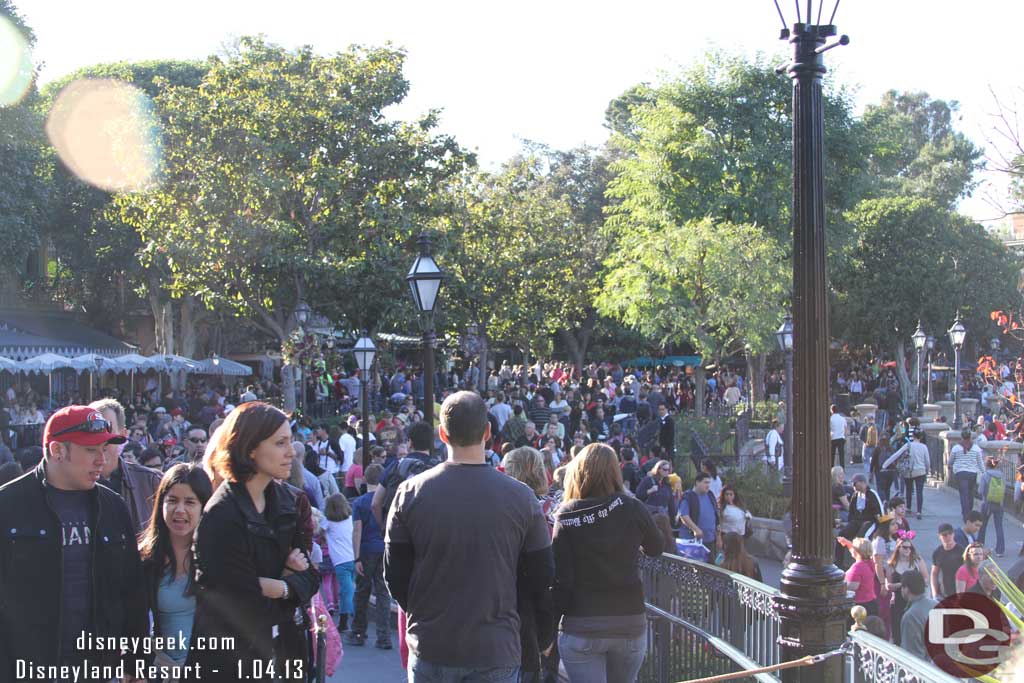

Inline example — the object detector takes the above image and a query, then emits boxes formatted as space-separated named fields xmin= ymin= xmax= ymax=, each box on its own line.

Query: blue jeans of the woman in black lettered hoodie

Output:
xmin=558 ymin=631 xmax=647 ymax=683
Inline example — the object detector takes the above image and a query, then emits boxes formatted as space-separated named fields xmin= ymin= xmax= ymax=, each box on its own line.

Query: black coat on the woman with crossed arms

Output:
xmin=188 ymin=481 xmax=321 ymax=682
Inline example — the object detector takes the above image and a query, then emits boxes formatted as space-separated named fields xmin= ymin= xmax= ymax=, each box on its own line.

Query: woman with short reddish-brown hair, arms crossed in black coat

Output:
xmin=188 ymin=401 xmax=321 ymax=682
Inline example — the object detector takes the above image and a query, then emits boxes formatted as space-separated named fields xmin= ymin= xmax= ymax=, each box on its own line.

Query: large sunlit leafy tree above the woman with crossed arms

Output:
xmin=117 ymin=38 xmax=468 ymax=409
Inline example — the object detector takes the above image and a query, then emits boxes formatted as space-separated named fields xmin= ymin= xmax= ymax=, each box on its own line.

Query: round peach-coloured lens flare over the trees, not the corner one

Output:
xmin=46 ymin=79 xmax=161 ymax=193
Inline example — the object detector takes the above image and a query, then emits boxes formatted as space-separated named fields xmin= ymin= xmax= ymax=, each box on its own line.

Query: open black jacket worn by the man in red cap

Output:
xmin=0 ymin=461 xmax=150 ymax=681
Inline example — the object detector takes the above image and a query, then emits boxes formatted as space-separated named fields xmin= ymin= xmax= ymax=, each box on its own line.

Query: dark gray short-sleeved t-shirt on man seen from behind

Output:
xmin=387 ymin=462 xmax=551 ymax=667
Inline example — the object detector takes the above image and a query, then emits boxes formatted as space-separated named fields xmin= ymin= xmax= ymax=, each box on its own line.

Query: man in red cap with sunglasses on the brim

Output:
xmin=0 ymin=405 xmax=148 ymax=681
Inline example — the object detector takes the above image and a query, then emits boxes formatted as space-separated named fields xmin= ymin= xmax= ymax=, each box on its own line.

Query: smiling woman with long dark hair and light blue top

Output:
xmin=138 ymin=463 xmax=213 ymax=666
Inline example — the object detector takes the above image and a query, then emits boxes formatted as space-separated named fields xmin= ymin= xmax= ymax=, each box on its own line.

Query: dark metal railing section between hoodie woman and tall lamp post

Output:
xmin=640 ymin=554 xmax=779 ymax=683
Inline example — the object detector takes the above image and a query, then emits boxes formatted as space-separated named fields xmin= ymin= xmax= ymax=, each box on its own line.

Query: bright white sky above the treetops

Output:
xmin=14 ymin=0 xmax=1024 ymax=219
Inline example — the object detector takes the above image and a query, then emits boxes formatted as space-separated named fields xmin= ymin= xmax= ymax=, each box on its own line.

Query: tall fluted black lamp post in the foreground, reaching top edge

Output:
xmin=774 ymin=0 xmax=851 ymax=683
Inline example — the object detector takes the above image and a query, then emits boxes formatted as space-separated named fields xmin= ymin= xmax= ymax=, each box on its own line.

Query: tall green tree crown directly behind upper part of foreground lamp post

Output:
xmin=606 ymin=52 xmax=866 ymax=243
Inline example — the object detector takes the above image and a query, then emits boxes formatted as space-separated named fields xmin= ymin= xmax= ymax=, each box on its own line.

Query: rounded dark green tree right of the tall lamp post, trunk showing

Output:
xmin=831 ymin=197 xmax=1021 ymax=400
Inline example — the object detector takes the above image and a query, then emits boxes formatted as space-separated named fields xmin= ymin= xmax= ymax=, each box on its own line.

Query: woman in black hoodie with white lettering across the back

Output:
xmin=552 ymin=443 xmax=664 ymax=683
